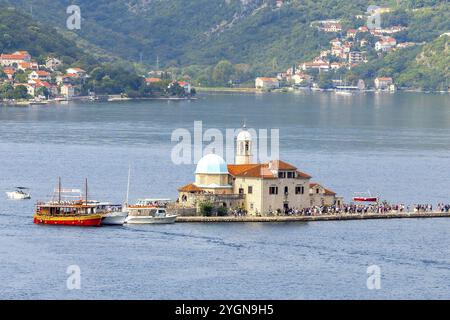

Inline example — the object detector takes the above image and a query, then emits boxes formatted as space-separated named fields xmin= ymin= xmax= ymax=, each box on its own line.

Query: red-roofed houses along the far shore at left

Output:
xmin=0 ymin=50 xmax=195 ymax=105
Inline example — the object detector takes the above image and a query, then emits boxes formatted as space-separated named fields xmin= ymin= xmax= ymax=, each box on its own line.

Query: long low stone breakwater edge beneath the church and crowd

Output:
xmin=177 ymin=212 xmax=450 ymax=222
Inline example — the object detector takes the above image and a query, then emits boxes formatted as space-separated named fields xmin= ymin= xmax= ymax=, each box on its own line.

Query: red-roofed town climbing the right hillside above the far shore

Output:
xmin=255 ymin=6 xmax=424 ymax=92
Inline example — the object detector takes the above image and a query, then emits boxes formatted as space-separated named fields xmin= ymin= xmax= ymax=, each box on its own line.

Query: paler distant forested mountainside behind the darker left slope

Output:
xmin=0 ymin=0 xmax=450 ymax=88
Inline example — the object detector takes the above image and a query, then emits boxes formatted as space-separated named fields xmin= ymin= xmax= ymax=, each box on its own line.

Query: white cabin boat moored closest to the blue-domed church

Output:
xmin=125 ymin=199 xmax=177 ymax=224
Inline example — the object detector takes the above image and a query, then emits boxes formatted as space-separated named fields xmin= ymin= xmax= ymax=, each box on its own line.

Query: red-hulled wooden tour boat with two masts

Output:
xmin=34 ymin=179 xmax=110 ymax=227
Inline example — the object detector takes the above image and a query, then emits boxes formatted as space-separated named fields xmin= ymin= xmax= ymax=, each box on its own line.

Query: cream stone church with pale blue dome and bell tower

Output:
xmin=177 ymin=127 xmax=342 ymax=215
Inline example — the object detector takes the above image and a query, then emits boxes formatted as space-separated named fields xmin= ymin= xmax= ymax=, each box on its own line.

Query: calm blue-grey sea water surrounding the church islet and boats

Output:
xmin=0 ymin=94 xmax=450 ymax=299
